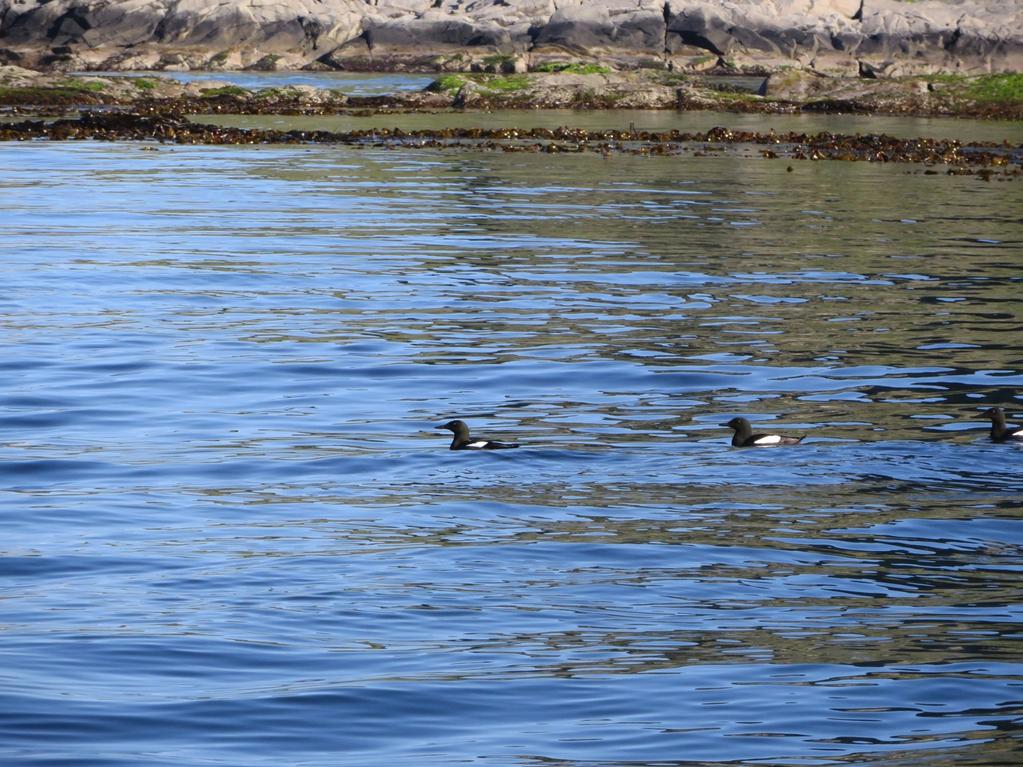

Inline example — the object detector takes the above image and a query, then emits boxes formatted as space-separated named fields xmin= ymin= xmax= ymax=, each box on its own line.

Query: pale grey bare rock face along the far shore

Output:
xmin=0 ymin=0 xmax=1023 ymax=73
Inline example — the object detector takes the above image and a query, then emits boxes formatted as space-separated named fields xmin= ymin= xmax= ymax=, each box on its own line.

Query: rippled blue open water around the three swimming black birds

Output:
xmin=0 ymin=143 xmax=1023 ymax=767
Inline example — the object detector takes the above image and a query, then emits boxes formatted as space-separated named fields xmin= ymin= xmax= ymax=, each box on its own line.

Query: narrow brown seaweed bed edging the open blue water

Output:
xmin=0 ymin=111 xmax=1023 ymax=180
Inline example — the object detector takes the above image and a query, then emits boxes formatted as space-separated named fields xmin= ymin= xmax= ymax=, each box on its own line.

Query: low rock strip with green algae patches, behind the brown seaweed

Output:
xmin=6 ymin=64 xmax=1023 ymax=120
